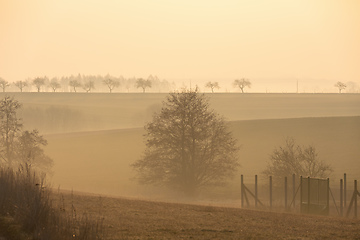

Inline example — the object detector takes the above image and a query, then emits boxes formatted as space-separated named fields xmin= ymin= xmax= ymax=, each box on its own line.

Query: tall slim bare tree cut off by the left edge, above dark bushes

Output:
xmin=0 ymin=96 xmax=22 ymax=166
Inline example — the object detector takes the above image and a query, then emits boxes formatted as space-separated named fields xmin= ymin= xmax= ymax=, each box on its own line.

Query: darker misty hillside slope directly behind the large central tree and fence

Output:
xmin=46 ymin=117 xmax=360 ymax=199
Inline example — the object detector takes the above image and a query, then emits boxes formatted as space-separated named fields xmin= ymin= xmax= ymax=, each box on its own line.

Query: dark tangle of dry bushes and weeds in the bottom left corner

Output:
xmin=0 ymin=165 xmax=104 ymax=240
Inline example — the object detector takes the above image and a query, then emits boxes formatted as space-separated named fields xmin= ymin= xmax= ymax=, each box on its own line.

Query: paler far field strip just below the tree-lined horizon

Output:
xmin=0 ymin=93 xmax=360 ymax=133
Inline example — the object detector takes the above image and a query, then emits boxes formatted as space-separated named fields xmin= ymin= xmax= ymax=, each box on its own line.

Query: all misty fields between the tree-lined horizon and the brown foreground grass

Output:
xmin=2 ymin=93 xmax=360 ymax=202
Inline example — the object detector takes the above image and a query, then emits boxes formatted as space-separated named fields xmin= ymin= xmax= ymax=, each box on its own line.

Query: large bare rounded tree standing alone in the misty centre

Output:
xmin=132 ymin=90 xmax=239 ymax=196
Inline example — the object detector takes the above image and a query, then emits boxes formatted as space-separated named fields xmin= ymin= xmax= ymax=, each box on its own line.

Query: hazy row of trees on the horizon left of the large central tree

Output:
xmin=0 ymin=74 xmax=174 ymax=93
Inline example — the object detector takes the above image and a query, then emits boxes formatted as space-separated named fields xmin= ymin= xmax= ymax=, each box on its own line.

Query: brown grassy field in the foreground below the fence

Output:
xmin=64 ymin=193 xmax=360 ymax=239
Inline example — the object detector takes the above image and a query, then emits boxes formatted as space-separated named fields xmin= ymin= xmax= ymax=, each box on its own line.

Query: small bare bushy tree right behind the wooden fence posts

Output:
xmin=263 ymin=138 xmax=333 ymax=182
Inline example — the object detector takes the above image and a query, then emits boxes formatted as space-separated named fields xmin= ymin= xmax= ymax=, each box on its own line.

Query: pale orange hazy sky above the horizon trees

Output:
xmin=0 ymin=0 xmax=360 ymax=90
